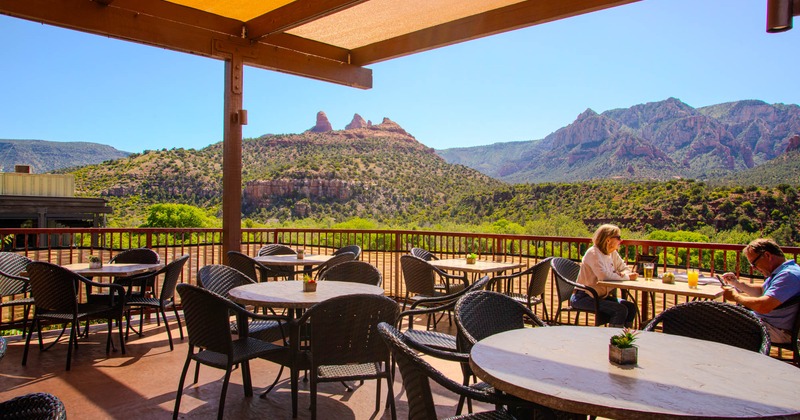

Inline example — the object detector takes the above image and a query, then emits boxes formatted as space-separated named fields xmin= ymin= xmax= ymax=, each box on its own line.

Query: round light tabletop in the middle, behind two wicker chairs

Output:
xmin=229 ymin=280 xmax=384 ymax=309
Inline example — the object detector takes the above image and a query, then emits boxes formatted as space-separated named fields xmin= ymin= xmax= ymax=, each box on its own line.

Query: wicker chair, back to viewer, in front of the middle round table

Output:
xmin=291 ymin=295 xmax=399 ymax=419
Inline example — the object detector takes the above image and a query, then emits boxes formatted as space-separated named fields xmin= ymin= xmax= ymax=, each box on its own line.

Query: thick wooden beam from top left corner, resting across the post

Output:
xmin=0 ymin=0 xmax=372 ymax=89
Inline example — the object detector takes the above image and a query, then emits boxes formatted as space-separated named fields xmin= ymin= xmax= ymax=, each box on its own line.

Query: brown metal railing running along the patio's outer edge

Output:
xmin=0 ymin=228 xmax=800 ymax=330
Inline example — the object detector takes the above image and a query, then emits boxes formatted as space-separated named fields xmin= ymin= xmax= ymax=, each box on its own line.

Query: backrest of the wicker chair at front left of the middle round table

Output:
xmin=176 ymin=283 xmax=239 ymax=355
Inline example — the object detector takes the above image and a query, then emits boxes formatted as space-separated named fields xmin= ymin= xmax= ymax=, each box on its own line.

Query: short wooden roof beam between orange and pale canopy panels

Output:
xmin=247 ymin=0 xmax=367 ymax=40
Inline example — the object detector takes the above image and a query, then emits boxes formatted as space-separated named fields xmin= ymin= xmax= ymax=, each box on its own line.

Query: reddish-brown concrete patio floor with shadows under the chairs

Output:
xmin=0 ymin=317 xmax=492 ymax=420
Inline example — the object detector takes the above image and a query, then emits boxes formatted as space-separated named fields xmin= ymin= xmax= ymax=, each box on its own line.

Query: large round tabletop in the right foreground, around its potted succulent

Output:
xmin=470 ymin=326 xmax=800 ymax=419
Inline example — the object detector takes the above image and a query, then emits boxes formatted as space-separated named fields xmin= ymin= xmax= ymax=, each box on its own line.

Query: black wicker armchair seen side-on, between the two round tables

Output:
xmin=395 ymin=276 xmax=493 ymax=351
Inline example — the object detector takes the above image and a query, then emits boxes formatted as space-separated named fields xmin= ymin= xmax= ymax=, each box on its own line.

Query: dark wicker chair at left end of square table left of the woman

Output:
xmin=400 ymin=255 xmax=469 ymax=310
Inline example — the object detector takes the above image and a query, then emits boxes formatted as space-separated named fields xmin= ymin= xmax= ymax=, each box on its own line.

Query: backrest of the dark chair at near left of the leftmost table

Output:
xmin=28 ymin=261 xmax=81 ymax=313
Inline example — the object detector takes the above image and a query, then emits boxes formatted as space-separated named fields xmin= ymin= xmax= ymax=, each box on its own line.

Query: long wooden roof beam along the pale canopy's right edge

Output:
xmin=350 ymin=0 xmax=640 ymax=66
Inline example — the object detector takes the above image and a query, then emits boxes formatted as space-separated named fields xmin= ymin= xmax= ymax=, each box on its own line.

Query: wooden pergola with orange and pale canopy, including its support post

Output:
xmin=0 ymin=0 xmax=638 ymax=256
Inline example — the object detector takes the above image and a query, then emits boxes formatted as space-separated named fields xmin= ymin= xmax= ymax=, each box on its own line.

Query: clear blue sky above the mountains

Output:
xmin=0 ymin=0 xmax=800 ymax=152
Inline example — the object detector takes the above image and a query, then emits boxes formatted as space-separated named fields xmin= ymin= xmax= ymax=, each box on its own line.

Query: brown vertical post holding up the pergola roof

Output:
xmin=222 ymin=47 xmax=244 ymax=262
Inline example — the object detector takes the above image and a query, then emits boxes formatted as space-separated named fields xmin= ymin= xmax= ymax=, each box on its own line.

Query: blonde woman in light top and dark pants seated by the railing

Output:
xmin=570 ymin=225 xmax=638 ymax=327
